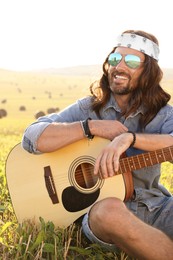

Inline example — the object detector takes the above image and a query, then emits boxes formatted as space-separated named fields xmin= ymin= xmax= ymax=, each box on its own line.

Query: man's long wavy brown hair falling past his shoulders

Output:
xmin=90 ymin=30 xmax=171 ymax=128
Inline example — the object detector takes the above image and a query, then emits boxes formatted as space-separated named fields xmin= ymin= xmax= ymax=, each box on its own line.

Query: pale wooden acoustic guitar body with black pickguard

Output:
xmin=6 ymin=137 xmax=132 ymax=228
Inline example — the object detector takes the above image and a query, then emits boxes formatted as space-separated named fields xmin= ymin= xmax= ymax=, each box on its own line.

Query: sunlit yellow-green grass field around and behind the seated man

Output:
xmin=0 ymin=70 xmax=173 ymax=260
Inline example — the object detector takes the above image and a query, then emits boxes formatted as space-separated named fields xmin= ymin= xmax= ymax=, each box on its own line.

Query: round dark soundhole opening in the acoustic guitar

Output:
xmin=75 ymin=163 xmax=98 ymax=189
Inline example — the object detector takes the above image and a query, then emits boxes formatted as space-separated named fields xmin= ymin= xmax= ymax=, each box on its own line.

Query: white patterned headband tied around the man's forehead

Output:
xmin=115 ymin=33 xmax=159 ymax=61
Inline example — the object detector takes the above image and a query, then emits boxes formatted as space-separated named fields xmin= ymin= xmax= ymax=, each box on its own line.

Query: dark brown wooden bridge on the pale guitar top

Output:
xmin=44 ymin=166 xmax=59 ymax=204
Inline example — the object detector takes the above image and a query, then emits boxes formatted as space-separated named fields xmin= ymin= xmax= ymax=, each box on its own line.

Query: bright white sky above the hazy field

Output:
xmin=0 ymin=0 xmax=173 ymax=71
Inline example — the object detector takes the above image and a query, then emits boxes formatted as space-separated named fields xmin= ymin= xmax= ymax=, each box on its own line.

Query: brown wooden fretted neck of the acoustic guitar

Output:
xmin=119 ymin=146 xmax=173 ymax=174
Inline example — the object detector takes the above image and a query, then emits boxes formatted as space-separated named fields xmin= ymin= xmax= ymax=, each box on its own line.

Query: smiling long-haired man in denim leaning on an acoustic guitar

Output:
xmin=22 ymin=30 xmax=173 ymax=259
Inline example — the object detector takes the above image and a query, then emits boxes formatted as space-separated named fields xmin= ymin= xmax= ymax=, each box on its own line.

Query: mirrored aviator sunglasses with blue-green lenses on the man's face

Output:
xmin=108 ymin=52 xmax=144 ymax=69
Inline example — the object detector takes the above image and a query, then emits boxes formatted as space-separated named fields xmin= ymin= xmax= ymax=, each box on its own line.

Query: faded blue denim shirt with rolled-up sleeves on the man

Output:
xmin=22 ymin=95 xmax=173 ymax=211
